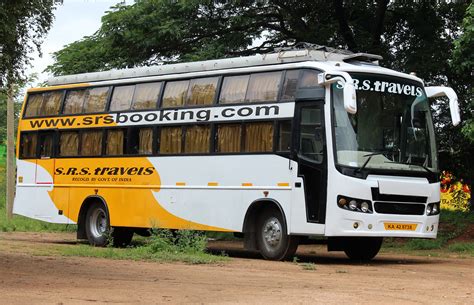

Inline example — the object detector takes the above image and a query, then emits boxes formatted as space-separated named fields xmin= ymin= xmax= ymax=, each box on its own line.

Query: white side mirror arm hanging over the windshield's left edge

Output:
xmin=318 ymin=71 xmax=357 ymax=114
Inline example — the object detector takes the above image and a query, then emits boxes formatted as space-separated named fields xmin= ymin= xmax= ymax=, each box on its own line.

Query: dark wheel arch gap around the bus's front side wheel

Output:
xmin=242 ymin=198 xmax=289 ymax=250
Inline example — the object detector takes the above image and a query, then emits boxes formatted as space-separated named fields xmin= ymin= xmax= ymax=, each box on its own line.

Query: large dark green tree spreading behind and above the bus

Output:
xmin=48 ymin=0 xmax=474 ymax=178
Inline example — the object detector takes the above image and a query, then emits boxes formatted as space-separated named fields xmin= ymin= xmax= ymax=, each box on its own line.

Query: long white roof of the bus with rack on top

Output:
xmin=47 ymin=45 xmax=382 ymax=86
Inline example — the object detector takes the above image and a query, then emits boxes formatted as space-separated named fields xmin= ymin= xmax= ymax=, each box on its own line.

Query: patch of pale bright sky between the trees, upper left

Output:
xmin=27 ymin=0 xmax=128 ymax=85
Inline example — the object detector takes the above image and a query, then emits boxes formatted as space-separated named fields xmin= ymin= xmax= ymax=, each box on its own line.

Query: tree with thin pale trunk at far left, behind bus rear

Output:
xmin=0 ymin=0 xmax=59 ymax=217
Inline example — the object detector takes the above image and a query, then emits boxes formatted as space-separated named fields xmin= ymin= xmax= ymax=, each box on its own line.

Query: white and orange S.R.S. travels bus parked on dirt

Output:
xmin=13 ymin=47 xmax=460 ymax=260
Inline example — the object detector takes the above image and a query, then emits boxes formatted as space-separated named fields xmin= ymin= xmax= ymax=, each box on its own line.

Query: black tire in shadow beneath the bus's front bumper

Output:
xmin=344 ymin=237 xmax=383 ymax=261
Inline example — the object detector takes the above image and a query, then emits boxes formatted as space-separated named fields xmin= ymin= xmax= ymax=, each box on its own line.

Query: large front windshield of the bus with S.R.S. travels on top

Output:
xmin=332 ymin=74 xmax=438 ymax=172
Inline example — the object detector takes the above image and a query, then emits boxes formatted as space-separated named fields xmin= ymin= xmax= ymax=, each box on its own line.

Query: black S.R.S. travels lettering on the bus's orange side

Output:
xmin=54 ymin=167 xmax=155 ymax=182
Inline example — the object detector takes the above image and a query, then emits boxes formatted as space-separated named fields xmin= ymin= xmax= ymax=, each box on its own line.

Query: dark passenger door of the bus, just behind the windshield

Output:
xmin=295 ymin=101 xmax=327 ymax=223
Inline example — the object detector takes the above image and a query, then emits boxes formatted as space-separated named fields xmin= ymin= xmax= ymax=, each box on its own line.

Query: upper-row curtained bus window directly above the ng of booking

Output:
xmin=186 ymin=77 xmax=219 ymax=105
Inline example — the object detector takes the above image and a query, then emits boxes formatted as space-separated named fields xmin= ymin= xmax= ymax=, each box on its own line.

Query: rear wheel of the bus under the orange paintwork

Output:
xmin=85 ymin=203 xmax=110 ymax=247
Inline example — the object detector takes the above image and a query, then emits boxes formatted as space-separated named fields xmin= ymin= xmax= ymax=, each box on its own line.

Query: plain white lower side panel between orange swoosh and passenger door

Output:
xmin=150 ymin=155 xmax=294 ymax=232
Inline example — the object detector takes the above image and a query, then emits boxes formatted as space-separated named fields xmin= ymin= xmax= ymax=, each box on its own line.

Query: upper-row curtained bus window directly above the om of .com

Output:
xmin=245 ymin=71 xmax=281 ymax=103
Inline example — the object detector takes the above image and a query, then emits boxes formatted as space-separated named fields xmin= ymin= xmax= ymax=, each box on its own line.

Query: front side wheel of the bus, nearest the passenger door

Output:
xmin=256 ymin=208 xmax=298 ymax=260
